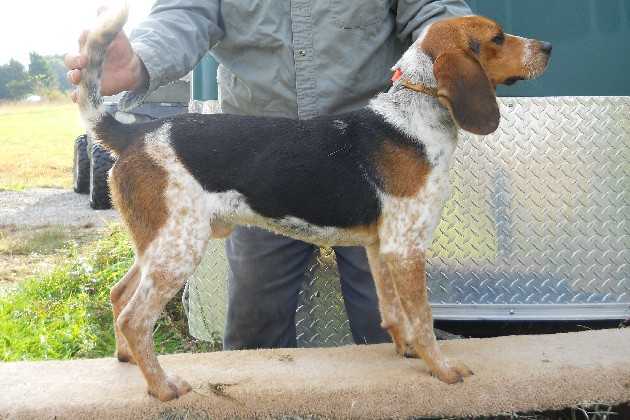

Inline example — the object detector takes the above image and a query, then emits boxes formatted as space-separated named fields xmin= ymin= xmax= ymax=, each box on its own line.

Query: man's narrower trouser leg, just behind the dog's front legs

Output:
xmin=334 ymin=246 xmax=391 ymax=344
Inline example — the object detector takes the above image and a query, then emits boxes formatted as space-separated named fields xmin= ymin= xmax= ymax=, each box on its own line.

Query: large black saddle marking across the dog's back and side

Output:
xmin=166 ymin=108 xmax=423 ymax=227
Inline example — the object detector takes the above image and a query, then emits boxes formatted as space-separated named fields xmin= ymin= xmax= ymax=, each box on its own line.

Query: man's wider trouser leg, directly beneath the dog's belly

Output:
xmin=223 ymin=226 xmax=315 ymax=350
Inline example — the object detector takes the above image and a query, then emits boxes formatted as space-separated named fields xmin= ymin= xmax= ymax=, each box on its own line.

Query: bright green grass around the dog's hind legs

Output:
xmin=0 ymin=226 xmax=219 ymax=361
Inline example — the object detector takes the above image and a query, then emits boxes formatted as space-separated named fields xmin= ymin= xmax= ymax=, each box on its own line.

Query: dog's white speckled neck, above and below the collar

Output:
xmin=369 ymin=46 xmax=457 ymax=165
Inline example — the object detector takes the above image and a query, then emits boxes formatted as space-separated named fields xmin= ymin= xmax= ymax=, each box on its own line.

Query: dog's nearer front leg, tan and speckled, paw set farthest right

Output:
xmin=380 ymin=251 xmax=472 ymax=384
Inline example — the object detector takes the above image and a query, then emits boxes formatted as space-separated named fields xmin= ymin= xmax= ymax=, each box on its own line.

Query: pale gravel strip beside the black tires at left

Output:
xmin=0 ymin=188 xmax=118 ymax=227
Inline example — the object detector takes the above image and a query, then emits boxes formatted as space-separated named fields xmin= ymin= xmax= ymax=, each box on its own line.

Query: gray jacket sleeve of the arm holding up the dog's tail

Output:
xmin=120 ymin=0 xmax=224 ymax=110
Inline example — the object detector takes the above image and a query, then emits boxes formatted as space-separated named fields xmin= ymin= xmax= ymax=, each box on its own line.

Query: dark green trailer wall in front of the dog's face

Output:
xmin=468 ymin=0 xmax=630 ymax=96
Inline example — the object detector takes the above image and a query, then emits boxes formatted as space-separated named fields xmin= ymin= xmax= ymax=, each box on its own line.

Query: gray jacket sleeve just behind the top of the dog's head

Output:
xmin=396 ymin=0 xmax=473 ymax=42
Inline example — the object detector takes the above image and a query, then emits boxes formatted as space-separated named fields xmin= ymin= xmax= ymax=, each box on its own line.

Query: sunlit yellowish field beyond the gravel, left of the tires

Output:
xmin=0 ymin=102 xmax=83 ymax=190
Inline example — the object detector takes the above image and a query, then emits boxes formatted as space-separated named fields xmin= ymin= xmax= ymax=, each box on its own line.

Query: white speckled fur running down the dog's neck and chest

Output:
xmin=370 ymin=44 xmax=457 ymax=257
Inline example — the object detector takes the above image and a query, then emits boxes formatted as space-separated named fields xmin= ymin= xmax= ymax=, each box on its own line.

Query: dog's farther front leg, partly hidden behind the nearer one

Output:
xmin=366 ymin=243 xmax=407 ymax=356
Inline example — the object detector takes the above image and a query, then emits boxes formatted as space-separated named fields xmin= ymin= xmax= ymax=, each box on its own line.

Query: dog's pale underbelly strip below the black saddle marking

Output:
xmin=206 ymin=190 xmax=377 ymax=246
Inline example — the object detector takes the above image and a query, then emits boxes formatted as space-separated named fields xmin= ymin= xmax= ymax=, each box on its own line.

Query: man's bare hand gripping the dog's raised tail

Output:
xmin=64 ymin=31 xmax=149 ymax=102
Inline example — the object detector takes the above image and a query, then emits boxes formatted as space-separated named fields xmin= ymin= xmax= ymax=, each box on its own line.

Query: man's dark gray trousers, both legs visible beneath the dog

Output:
xmin=223 ymin=226 xmax=390 ymax=350
